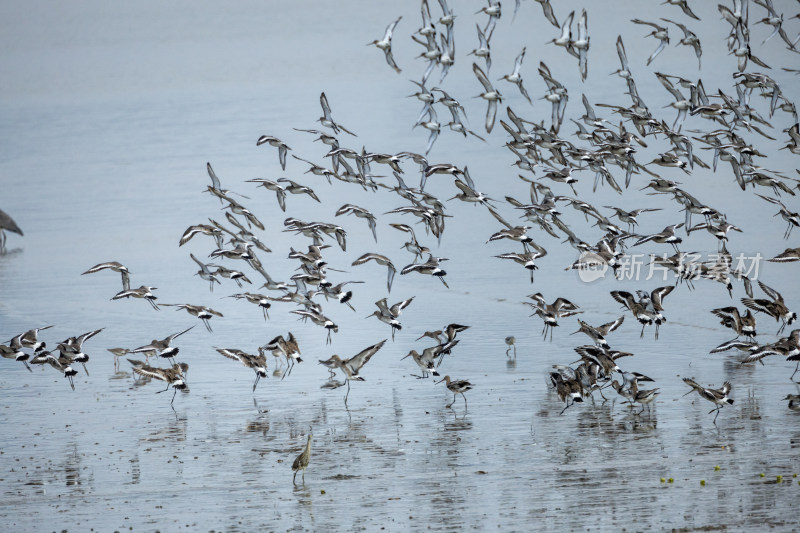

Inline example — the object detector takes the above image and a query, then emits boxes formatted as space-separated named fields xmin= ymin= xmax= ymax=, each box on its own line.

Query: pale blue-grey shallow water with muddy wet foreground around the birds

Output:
xmin=0 ymin=2 xmax=800 ymax=531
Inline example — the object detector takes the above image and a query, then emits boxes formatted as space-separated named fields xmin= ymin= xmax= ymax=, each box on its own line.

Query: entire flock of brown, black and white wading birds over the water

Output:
xmin=0 ymin=0 xmax=800 ymax=482
